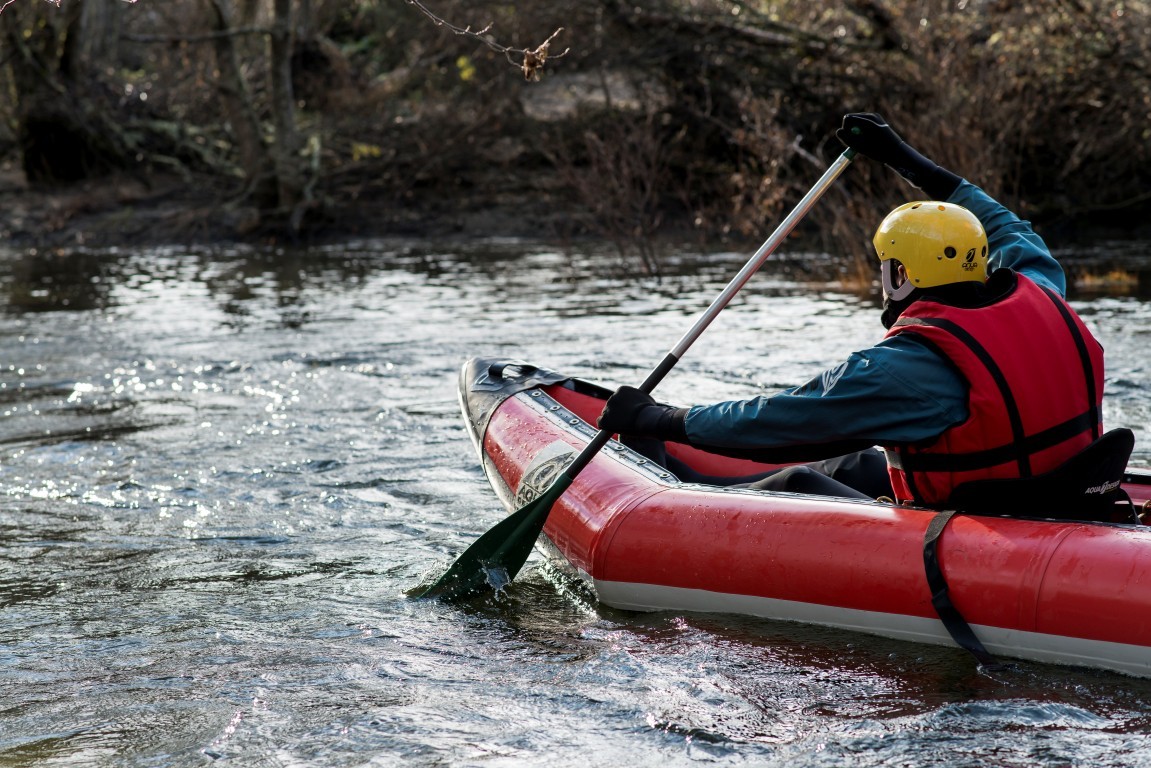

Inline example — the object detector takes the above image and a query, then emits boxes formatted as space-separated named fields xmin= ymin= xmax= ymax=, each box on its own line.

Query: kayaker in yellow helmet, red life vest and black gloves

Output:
xmin=600 ymin=113 xmax=1103 ymax=507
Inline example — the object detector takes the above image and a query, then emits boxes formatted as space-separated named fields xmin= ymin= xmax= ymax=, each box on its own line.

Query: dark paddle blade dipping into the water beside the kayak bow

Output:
xmin=416 ymin=474 xmax=572 ymax=601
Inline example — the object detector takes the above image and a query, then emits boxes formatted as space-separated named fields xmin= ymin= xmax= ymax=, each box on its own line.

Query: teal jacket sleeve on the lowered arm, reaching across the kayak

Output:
xmin=685 ymin=334 xmax=968 ymax=463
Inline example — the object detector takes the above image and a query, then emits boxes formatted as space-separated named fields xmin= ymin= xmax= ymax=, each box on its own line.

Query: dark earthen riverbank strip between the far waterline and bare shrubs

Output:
xmin=0 ymin=158 xmax=1151 ymax=259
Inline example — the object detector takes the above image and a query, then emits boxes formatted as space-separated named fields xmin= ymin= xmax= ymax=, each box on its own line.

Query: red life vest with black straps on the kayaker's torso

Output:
xmin=885 ymin=274 xmax=1103 ymax=507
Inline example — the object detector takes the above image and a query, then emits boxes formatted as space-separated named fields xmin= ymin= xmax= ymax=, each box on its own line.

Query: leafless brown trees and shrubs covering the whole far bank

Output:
xmin=0 ymin=0 xmax=1151 ymax=272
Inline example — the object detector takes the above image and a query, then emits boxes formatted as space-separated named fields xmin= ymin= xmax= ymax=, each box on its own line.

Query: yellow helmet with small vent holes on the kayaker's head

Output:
xmin=871 ymin=200 xmax=988 ymax=301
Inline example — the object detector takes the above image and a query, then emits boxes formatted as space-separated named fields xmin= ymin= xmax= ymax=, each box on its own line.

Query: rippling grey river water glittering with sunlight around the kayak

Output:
xmin=0 ymin=242 xmax=1151 ymax=768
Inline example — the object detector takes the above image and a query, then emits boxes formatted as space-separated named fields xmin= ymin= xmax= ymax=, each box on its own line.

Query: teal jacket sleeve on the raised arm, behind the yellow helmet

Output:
xmin=947 ymin=181 xmax=1067 ymax=298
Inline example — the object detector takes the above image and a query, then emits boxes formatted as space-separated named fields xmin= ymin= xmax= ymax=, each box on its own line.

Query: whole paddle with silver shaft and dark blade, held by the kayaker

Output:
xmin=417 ymin=150 xmax=855 ymax=600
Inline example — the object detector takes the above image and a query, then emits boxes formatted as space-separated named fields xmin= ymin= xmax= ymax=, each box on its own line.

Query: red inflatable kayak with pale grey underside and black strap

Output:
xmin=459 ymin=359 xmax=1151 ymax=677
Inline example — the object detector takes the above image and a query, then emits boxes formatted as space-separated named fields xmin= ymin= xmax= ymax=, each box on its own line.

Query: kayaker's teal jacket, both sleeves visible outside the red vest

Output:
xmin=685 ymin=181 xmax=1067 ymax=462
